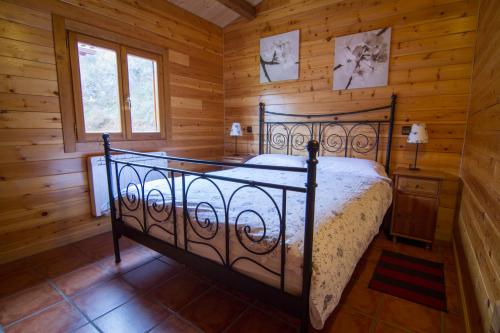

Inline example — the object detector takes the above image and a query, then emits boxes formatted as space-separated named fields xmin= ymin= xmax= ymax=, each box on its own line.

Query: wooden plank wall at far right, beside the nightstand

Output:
xmin=457 ymin=0 xmax=500 ymax=330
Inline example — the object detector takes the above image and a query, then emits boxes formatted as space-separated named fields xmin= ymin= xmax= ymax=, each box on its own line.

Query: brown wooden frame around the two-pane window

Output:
xmin=52 ymin=14 xmax=172 ymax=153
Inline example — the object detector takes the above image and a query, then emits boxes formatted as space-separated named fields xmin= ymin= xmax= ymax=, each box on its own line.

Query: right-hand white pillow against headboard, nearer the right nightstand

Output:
xmin=318 ymin=156 xmax=387 ymax=178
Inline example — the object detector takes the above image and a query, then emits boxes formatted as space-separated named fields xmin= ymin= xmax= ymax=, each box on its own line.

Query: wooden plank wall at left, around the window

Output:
xmin=0 ymin=0 xmax=224 ymax=263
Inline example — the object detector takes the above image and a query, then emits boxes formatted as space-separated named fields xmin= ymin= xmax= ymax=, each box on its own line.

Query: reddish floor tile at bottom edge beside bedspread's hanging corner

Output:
xmin=321 ymin=310 xmax=372 ymax=333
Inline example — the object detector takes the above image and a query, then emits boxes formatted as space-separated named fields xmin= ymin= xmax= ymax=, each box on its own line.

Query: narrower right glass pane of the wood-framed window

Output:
xmin=127 ymin=55 xmax=160 ymax=133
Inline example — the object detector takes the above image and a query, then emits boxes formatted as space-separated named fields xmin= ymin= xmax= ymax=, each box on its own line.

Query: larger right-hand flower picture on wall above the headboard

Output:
xmin=333 ymin=28 xmax=391 ymax=90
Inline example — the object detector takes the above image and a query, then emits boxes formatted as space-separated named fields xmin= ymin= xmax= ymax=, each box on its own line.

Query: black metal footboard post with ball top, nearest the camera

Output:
xmin=300 ymin=140 xmax=319 ymax=333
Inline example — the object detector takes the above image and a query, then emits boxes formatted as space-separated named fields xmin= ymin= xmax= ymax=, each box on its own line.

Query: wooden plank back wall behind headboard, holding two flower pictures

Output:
xmin=224 ymin=0 xmax=478 ymax=240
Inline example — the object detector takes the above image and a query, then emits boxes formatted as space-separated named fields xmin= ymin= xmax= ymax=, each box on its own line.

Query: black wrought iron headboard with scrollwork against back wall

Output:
xmin=259 ymin=94 xmax=397 ymax=173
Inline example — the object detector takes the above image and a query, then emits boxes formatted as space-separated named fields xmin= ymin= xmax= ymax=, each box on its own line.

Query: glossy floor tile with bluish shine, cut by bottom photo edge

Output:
xmin=95 ymin=297 xmax=170 ymax=333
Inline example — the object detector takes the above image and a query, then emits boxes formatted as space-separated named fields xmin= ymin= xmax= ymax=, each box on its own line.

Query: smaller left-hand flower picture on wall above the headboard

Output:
xmin=260 ymin=30 xmax=299 ymax=83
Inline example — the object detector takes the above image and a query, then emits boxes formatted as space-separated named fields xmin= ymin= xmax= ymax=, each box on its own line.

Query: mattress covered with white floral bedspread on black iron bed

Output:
xmin=115 ymin=154 xmax=392 ymax=329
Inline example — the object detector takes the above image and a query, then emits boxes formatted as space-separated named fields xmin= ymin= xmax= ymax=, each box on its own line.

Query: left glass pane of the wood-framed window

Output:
xmin=78 ymin=42 xmax=121 ymax=133
